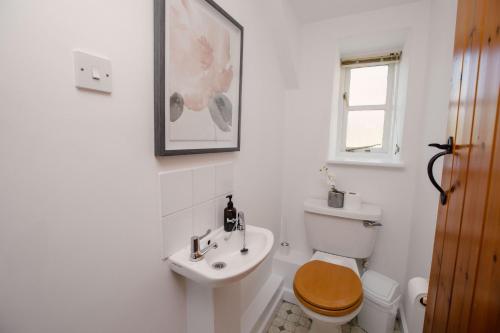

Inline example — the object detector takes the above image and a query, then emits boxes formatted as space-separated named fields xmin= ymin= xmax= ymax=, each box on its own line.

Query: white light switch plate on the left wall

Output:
xmin=73 ymin=51 xmax=112 ymax=93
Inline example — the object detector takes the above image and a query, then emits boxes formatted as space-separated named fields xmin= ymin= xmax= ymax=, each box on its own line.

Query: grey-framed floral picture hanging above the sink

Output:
xmin=154 ymin=0 xmax=243 ymax=156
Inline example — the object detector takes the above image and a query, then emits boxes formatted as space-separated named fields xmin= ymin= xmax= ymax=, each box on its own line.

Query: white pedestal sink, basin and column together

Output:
xmin=168 ymin=225 xmax=274 ymax=333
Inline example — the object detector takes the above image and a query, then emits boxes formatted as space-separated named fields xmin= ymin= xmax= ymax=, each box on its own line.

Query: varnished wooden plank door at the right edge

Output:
xmin=424 ymin=0 xmax=500 ymax=332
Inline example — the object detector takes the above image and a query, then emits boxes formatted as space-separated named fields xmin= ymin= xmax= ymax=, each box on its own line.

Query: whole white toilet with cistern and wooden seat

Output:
xmin=293 ymin=199 xmax=382 ymax=333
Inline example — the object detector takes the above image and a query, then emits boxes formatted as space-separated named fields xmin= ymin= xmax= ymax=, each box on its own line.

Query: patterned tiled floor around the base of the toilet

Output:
xmin=267 ymin=301 xmax=401 ymax=333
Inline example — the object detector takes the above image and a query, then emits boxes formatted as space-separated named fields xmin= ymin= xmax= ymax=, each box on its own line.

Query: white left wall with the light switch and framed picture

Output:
xmin=0 ymin=0 xmax=284 ymax=333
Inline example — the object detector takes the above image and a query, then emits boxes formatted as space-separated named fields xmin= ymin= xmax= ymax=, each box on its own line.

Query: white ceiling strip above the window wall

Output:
xmin=289 ymin=0 xmax=417 ymax=23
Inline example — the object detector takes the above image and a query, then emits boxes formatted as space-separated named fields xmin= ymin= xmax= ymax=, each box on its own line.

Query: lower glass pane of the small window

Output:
xmin=346 ymin=110 xmax=385 ymax=151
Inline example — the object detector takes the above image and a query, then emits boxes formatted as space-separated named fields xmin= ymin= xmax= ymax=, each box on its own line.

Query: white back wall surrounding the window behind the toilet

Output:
xmin=283 ymin=1 xmax=429 ymax=286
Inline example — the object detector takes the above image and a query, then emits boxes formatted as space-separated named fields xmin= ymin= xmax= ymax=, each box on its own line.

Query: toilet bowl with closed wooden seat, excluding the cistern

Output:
xmin=293 ymin=251 xmax=363 ymax=333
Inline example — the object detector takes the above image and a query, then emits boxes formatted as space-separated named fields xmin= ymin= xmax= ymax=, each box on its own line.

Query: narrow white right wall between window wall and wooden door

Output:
xmin=407 ymin=0 xmax=457 ymax=279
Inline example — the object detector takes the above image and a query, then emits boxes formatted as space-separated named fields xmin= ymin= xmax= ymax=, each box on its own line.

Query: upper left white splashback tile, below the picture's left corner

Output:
xmin=160 ymin=170 xmax=193 ymax=216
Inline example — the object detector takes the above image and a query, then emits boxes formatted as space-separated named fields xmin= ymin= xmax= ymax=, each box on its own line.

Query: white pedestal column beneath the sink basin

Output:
xmin=186 ymin=279 xmax=241 ymax=333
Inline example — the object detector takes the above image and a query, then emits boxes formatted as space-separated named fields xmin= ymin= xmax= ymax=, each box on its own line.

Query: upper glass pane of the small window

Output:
xmin=349 ymin=65 xmax=389 ymax=106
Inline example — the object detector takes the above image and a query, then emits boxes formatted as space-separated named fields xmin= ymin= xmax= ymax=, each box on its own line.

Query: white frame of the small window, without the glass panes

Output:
xmin=337 ymin=61 xmax=399 ymax=159
